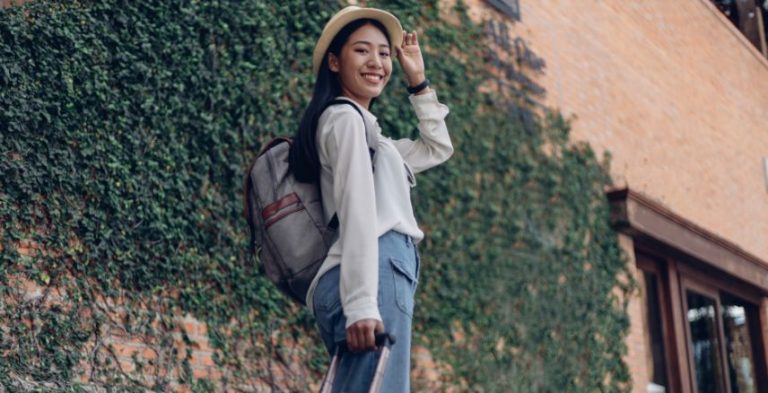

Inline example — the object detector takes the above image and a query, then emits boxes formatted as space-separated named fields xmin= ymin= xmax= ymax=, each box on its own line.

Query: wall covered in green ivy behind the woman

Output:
xmin=0 ymin=0 xmax=631 ymax=392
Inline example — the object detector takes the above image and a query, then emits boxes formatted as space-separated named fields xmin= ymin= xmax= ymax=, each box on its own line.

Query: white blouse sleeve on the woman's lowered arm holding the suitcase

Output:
xmin=322 ymin=108 xmax=381 ymax=327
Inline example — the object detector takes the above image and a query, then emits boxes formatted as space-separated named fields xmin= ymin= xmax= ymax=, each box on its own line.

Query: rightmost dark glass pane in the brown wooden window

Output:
xmin=722 ymin=296 xmax=755 ymax=393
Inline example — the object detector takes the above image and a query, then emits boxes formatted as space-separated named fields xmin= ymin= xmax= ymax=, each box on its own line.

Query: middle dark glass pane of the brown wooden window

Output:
xmin=687 ymin=291 xmax=725 ymax=393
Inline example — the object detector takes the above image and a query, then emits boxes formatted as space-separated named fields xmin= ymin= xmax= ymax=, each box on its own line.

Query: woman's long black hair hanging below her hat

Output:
xmin=289 ymin=19 xmax=392 ymax=183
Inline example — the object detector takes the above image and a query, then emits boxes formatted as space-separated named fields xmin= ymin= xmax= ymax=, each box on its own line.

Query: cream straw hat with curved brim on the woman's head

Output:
xmin=312 ymin=5 xmax=403 ymax=75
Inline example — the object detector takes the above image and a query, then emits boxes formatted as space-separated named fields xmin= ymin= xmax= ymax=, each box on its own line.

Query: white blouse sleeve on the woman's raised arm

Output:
xmin=392 ymin=91 xmax=453 ymax=173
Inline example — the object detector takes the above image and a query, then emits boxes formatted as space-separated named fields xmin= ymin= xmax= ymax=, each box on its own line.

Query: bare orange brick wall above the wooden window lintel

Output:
xmin=467 ymin=0 xmax=768 ymax=259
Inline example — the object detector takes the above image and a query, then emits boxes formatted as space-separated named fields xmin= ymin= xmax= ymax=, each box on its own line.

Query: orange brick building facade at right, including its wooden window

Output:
xmin=468 ymin=0 xmax=768 ymax=393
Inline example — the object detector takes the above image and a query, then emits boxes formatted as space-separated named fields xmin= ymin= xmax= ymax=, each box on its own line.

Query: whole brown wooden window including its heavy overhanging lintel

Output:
xmin=608 ymin=188 xmax=768 ymax=393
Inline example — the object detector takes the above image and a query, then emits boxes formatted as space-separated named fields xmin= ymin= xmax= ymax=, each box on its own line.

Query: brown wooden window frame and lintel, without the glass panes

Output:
xmin=607 ymin=188 xmax=768 ymax=393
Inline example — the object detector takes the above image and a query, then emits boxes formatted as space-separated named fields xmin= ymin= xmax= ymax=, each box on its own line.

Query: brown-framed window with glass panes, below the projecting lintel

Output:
xmin=635 ymin=249 xmax=768 ymax=393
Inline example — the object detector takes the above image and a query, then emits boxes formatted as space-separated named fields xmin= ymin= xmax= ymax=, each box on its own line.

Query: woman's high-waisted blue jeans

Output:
xmin=313 ymin=231 xmax=419 ymax=393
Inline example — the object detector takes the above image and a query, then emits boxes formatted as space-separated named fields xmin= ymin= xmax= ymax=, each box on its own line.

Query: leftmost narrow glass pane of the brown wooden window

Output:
xmin=644 ymin=272 xmax=667 ymax=388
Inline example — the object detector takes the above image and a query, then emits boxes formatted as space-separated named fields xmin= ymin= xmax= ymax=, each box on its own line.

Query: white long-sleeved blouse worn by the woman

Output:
xmin=306 ymin=91 xmax=453 ymax=327
